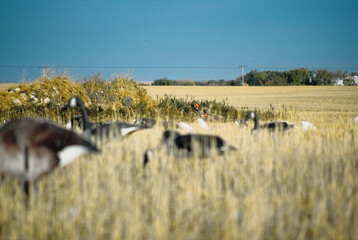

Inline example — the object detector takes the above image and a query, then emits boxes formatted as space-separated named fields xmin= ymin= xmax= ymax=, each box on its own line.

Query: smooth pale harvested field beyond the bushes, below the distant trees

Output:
xmin=144 ymin=86 xmax=358 ymax=114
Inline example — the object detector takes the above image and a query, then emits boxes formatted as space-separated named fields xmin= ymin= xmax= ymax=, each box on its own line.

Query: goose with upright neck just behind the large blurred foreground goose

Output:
xmin=67 ymin=97 xmax=155 ymax=140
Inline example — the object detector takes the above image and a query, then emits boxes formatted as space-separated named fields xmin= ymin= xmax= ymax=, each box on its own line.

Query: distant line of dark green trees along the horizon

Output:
xmin=152 ymin=68 xmax=358 ymax=86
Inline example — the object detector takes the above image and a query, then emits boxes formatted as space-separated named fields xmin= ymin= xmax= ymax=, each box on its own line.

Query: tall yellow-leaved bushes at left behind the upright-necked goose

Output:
xmin=0 ymin=72 xmax=155 ymax=120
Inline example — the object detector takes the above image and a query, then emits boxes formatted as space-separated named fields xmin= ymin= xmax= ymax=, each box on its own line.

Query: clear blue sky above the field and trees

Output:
xmin=0 ymin=0 xmax=358 ymax=82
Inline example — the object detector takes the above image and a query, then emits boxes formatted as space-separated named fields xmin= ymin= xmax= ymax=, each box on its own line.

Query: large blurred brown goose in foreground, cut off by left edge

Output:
xmin=0 ymin=119 xmax=99 ymax=194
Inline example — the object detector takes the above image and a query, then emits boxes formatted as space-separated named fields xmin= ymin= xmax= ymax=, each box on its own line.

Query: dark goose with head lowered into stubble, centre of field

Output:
xmin=143 ymin=130 xmax=237 ymax=167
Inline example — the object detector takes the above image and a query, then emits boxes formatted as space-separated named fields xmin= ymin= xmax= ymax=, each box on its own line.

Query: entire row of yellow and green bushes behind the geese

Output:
xmin=0 ymin=72 xmax=288 ymax=123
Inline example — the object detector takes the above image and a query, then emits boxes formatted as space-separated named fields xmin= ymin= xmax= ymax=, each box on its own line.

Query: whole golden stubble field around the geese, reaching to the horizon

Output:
xmin=0 ymin=86 xmax=358 ymax=240
